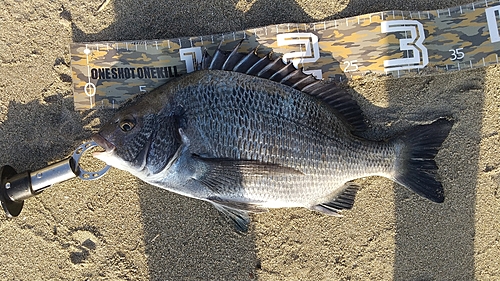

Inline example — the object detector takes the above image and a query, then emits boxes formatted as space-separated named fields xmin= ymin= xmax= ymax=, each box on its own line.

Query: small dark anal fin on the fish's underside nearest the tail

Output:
xmin=310 ymin=182 xmax=359 ymax=217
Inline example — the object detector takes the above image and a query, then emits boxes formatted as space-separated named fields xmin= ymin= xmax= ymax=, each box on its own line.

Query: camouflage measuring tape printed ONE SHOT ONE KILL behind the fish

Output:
xmin=71 ymin=0 xmax=500 ymax=110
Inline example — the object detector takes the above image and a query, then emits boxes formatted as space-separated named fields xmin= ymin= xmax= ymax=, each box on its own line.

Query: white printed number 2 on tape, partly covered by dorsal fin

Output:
xmin=276 ymin=33 xmax=323 ymax=79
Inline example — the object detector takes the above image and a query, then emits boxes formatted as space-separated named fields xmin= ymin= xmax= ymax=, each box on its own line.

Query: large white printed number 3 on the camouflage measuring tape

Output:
xmin=380 ymin=20 xmax=429 ymax=71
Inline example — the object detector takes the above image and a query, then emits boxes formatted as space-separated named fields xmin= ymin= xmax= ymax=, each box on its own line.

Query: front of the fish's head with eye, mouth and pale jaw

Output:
xmin=92 ymin=107 xmax=156 ymax=175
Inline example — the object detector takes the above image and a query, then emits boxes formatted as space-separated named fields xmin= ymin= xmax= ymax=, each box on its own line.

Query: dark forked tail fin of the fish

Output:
xmin=394 ymin=118 xmax=453 ymax=203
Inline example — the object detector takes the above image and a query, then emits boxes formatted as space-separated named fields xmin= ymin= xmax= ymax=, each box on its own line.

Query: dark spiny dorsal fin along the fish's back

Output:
xmin=200 ymin=41 xmax=366 ymax=132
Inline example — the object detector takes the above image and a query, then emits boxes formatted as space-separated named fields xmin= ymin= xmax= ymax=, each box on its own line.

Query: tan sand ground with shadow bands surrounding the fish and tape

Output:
xmin=0 ymin=0 xmax=500 ymax=281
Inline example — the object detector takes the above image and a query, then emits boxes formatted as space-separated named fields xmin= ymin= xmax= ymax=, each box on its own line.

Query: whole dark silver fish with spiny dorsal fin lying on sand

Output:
xmin=93 ymin=43 xmax=452 ymax=231
